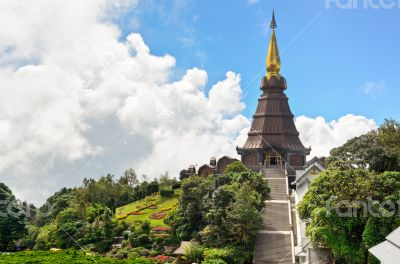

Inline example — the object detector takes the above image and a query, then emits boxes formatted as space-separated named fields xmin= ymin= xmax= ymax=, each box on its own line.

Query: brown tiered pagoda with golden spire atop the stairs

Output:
xmin=236 ymin=13 xmax=311 ymax=172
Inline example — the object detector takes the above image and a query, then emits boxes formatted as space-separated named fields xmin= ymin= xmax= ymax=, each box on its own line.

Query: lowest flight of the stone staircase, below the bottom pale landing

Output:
xmin=253 ymin=232 xmax=292 ymax=264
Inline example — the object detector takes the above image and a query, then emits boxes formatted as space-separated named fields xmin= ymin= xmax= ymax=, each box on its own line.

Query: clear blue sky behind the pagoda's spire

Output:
xmin=119 ymin=0 xmax=400 ymax=124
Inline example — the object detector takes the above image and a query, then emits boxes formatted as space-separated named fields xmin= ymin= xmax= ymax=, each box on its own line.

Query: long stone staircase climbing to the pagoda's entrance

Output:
xmin=253 ymin=168 xmax=294 ymax=264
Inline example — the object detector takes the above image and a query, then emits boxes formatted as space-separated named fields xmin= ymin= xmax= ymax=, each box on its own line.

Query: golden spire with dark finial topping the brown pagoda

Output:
xmin=267 ymin=11 xmax=281 ymax=79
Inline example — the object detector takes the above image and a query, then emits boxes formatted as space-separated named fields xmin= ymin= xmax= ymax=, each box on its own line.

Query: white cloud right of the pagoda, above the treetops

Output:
xmin=295 ymin=114 xmax=376 ymax=157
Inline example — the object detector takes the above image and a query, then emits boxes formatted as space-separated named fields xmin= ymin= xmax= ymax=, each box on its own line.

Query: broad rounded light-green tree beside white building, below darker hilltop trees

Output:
xmin=298 ymin=169 xmax=400 ymax=264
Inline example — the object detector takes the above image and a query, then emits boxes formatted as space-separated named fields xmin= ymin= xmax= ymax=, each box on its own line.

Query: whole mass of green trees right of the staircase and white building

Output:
xmin=298 ymin=120 xmax=400 ymax=264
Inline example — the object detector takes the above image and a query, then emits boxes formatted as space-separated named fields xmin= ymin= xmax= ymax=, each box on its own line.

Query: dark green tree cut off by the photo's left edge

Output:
xmin=0 ymin=183 xmax=27 ymax=251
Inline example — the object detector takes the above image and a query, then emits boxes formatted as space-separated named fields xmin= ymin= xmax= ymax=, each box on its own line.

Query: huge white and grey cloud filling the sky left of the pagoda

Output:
xmin=0 ymin=0 xmax=249 ymax=203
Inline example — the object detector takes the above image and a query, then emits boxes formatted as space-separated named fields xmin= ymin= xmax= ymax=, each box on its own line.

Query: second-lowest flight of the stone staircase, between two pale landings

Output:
xmin=261 ymin=202 xmax=291 ymax=231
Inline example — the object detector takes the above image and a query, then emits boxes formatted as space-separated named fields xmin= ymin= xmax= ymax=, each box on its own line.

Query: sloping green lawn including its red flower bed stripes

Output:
xmin=116 ymin=190 xmax=180 ymax=227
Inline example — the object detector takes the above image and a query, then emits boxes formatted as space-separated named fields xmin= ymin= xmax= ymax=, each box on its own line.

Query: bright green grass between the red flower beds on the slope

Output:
xmin=116 ymin=191 xmax=179 ymax=227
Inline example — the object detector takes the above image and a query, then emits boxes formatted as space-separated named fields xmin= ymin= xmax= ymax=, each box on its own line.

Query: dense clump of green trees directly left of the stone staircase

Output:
xmin=172 ymin=162 xmax=269 ymax=263
